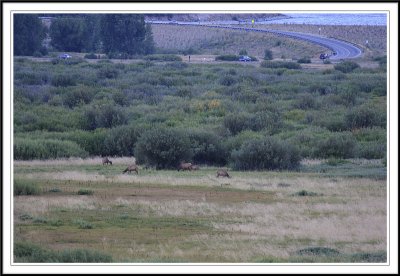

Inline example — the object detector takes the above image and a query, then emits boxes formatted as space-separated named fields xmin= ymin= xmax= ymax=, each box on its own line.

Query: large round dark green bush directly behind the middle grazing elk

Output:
xmin=135 ymin=128 xmax=192 ymax=169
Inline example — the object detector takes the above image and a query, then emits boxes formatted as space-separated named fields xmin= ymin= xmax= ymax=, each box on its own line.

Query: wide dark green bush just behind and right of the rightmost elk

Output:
xmin=232 ymin=137 xmax=300 ymax=170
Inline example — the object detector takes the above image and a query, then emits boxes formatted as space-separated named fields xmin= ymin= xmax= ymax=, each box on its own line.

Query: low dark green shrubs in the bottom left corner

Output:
xmin=14 ymin=241 xmax=112 ymax=263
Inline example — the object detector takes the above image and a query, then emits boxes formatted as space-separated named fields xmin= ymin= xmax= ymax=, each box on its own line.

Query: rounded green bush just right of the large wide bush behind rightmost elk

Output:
xmin=314 ymin=132 xmax=357 ymax=158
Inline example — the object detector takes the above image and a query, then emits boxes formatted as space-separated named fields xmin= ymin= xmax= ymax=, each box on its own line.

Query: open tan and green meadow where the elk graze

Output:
xmin=13 ymin=158 xmax=387 ymax=263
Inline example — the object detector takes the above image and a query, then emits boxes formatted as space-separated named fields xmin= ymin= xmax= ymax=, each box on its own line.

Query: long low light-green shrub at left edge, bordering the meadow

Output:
xmin=14 ymin=138 xmax=88 ymax=160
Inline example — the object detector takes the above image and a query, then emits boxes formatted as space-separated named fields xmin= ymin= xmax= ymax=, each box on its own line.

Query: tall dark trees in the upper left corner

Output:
xmin=14 ymin=14 xmax=154 ymax=57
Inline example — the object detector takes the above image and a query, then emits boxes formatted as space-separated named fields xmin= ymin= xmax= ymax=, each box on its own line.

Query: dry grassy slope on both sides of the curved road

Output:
xmin=152 ymin=24 xmax=387 ymax=59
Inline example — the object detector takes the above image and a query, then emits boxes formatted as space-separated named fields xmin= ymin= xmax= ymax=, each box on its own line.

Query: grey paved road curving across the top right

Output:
xmin=149 ymin=21 xmax=362 ymax=59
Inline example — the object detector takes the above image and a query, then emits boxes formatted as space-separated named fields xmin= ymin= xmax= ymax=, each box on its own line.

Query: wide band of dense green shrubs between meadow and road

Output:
xmin=14 ymin=56 xmax=386 ymax=170
